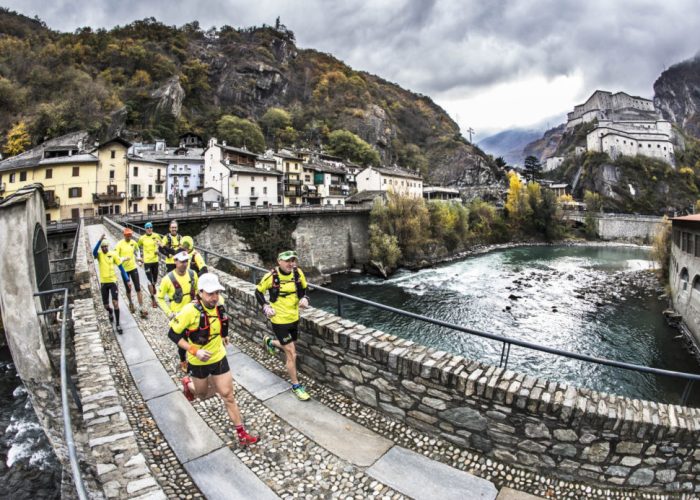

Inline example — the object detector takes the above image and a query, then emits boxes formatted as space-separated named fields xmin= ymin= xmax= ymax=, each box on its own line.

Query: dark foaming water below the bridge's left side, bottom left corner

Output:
xmin=0 ymin=347 xmax=61 ymax=500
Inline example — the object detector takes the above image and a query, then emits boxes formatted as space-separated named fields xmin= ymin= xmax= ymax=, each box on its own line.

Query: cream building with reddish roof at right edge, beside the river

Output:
xmin=669 ymin=214 xmax=700 ymax=349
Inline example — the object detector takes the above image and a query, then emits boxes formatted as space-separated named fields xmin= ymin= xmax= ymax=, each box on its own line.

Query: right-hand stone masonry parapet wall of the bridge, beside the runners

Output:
xmin=216 ymin=271 xmax=700 ymax=493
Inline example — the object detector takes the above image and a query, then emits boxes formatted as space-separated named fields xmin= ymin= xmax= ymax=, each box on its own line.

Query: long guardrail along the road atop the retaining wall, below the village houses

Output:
xmin=109 ymin=205 xmax=372 ymax=222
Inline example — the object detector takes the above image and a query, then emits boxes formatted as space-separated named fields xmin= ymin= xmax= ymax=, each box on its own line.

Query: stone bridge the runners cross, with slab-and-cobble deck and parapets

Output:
xmin=0 ymin=189 xmax=700 ymax=499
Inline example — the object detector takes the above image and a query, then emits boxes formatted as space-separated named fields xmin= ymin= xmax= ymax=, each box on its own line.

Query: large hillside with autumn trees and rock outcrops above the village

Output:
xmin=0 ymin=9 xmax=499 ymax=187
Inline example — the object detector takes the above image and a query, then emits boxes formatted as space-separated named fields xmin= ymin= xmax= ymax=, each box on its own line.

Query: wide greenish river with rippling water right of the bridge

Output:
xmin=312 ymin=246 xmax=700 ymax=406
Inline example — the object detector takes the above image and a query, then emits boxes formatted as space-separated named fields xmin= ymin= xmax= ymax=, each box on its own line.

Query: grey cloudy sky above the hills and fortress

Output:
xmin=5 ymin=0 xmax=700 ymax=138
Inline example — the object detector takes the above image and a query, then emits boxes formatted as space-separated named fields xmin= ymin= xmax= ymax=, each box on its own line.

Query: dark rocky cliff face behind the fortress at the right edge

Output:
xmin=654 ymin=56 xmax=700 ymax=137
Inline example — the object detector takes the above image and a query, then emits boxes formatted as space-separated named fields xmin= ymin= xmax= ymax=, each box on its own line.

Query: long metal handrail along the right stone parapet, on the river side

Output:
xmin=110 ymin=217 xmax=700 ymax=405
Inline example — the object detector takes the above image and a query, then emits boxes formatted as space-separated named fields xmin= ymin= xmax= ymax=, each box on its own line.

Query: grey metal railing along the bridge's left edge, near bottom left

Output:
xmin=34 ymin=288 xmax=88 ymax=500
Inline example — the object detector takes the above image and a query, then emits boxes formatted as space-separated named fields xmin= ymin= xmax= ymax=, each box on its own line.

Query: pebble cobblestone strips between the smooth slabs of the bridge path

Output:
xmin=96 ymin=274 xmax=669 ymax=499
